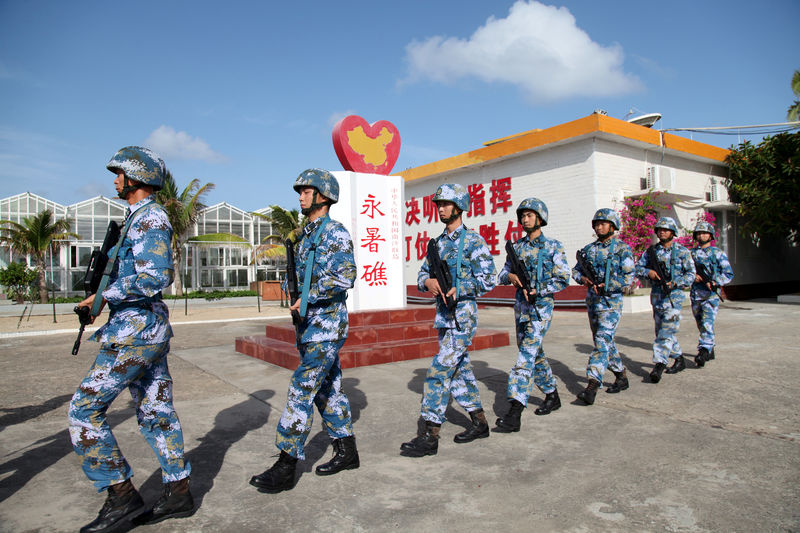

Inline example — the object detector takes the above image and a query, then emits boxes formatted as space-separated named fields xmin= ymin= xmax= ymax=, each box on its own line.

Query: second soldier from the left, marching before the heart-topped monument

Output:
xmin=250 ymin=168 xmax=359 ymax=493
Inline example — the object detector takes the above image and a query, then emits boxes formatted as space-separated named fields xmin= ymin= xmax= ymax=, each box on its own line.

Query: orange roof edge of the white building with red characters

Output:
xmin=394 ymin=114 xmax=730 ymax=181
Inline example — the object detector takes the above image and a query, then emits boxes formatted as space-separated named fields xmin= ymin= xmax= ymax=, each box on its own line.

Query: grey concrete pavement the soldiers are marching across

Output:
xmin=0 ymin=300 xmax=800 ymax=532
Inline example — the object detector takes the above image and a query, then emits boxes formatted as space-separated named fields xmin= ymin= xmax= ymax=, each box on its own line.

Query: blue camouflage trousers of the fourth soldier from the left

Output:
xmin=506 ymin=317 xmax=556 ymax=405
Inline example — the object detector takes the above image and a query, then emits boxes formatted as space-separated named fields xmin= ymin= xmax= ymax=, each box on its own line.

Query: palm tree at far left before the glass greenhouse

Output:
xmin=0 ymin=209 xmax=78 ymax=303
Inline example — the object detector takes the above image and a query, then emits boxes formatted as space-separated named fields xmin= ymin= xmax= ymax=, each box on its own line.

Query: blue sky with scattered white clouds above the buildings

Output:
xmin=0 ymin=0 xmax=800 ymax=210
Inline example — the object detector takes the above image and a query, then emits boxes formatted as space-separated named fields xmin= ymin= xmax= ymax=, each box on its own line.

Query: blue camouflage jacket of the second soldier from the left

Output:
xmin=295 ymin=214 xmax=356 ymax=344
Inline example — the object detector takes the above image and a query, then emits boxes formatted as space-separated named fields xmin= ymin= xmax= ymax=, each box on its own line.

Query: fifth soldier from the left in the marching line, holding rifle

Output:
xmin=572 ymin=209 xmax=635 ymax=405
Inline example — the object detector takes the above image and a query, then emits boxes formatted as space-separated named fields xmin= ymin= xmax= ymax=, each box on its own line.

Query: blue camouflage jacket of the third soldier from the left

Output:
xmin=417 ymin=224 xmax=497 ymax=332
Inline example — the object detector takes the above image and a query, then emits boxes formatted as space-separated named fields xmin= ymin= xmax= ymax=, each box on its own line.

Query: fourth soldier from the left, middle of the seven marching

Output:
xmin=495 ymin=198 xmax=570 ymax=433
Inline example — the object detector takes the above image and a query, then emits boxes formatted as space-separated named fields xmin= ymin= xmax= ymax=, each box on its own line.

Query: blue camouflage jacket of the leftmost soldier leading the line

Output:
xmin=91 ymin=196 xmax=175 ymax=345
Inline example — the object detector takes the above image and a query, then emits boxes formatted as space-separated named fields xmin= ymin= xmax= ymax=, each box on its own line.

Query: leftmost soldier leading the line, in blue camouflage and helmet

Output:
xmin=69 ymin=146 xmax=194 ymax=533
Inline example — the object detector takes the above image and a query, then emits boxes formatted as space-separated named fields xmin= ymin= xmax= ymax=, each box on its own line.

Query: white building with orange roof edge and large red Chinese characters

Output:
xmin=398 ymin=114 xmax=800 ymax=296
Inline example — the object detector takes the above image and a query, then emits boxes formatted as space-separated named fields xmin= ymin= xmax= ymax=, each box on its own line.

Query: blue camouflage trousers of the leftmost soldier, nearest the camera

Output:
xmin=69 ymin=341 xmax=191 ymax=492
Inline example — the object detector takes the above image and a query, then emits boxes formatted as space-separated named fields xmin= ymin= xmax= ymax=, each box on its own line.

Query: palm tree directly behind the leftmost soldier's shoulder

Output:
xmin=156 ymin=170 xmax=216 ymax=296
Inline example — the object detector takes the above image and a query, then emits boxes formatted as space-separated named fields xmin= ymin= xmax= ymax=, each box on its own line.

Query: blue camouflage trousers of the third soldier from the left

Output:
xmin=420 ymin=328 xmax=483 ymax=424
